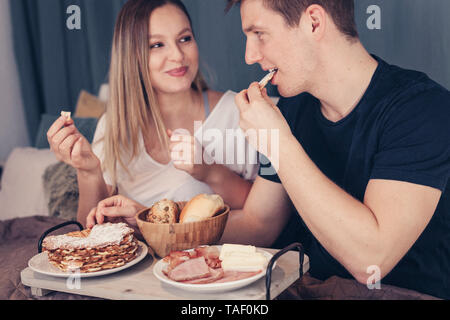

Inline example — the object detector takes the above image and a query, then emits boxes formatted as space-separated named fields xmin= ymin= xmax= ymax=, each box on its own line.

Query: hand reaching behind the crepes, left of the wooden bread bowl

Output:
xmin=86 ymin=195 xmax=146 ymax=229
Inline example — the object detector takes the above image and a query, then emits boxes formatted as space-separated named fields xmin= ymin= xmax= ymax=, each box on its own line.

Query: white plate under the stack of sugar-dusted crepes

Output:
xmin=28 ymin=241 xmax=148 ymax=278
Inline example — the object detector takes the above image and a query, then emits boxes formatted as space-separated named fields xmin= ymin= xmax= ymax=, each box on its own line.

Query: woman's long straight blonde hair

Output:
xmin=102 ymin=0 xmax=208 ymax=189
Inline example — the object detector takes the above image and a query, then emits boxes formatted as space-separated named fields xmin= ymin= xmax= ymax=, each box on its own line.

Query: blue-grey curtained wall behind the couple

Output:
xmin=0 ymin=0 xmax=450 ymax=162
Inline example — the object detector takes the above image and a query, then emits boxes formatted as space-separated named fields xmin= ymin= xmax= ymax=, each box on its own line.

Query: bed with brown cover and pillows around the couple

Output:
xmin=0 ymin=90 xmax=435 ymax=300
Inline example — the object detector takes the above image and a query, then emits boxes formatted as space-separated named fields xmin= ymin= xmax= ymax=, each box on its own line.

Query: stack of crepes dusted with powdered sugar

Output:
xmin=43 ymin=223 xmax=139 ymax=273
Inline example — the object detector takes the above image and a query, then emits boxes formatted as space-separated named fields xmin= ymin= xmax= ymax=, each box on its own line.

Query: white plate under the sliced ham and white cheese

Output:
xmin=153 ymin=246 xmax=276 ymax=293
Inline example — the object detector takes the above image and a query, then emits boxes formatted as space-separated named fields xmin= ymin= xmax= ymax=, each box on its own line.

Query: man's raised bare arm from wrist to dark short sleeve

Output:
xmin=278 ymin=136 xmax=441 ymax=283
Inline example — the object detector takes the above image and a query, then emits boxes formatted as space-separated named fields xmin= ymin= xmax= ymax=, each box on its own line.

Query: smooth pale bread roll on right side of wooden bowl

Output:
xmin=180 ymin=194 xmax=225 ymax=223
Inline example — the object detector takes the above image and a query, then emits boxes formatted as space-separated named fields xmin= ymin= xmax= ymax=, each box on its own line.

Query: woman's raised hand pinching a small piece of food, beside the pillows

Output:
xmin=47 ymin=116 xmax=100 ymax=172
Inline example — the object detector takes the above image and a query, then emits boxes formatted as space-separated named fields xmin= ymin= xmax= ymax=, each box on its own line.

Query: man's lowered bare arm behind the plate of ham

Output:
xmin=220 ymin=177 xmax=291 ymax=247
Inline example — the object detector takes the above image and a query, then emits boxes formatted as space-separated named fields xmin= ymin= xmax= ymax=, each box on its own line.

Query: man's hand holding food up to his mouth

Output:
xmin=235 ymin=82 xmax=292 ymax=161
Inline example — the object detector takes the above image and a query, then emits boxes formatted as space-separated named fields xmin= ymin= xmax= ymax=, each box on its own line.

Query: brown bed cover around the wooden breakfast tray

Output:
xmin=0 ymin=208 xmax=435 ymax=300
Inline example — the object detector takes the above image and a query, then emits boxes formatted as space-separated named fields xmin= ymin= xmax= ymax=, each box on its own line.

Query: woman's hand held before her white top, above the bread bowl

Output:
xmin=168 ymin=130 xmax=212 ymax=181
